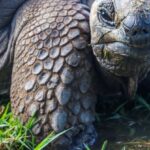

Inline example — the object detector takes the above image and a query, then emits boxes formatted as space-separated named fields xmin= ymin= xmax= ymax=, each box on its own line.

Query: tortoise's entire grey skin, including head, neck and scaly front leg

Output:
xmin=0 ymin=0 xmax=150 ymax=150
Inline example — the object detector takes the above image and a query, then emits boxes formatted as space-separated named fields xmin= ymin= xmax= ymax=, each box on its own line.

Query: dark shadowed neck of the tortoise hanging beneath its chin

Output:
xmin=100 ymin=65 xmax=139 ymax=99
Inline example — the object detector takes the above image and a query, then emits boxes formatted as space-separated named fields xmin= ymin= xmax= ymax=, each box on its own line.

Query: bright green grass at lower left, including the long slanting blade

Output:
xmin=0 ymin=104 xmax=70 ymax=150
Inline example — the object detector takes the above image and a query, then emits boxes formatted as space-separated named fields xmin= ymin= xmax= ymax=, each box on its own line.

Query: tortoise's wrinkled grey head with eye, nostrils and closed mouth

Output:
xmin=90 ymin=0 xmax=150 ymax=96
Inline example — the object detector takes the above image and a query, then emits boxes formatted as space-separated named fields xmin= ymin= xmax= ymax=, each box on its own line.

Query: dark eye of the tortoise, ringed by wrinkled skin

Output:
xmin=98 ymin=8 xmax=115 ymax=27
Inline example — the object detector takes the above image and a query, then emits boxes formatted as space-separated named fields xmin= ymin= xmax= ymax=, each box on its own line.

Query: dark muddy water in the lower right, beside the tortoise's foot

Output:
xmin=91 ymin=114 xmax=150 ymax=150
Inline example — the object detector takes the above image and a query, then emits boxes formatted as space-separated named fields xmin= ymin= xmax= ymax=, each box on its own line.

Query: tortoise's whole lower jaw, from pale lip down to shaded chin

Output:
xmin=93 ymin=42 xmax=150 ymax=77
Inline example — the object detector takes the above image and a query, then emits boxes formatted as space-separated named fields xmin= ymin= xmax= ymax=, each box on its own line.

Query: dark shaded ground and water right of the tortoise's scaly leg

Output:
xmin=1 ymin=94 xmax=150 ymax=150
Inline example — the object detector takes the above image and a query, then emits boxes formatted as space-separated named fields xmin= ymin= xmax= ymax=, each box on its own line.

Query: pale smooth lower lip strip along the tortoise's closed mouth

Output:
xmin=93 ymin=42 xmax=150 ymax=60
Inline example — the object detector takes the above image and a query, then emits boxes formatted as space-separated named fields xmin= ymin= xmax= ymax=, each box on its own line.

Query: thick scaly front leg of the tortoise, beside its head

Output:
xmin=11 ymin=0 xmax=96 ymax=149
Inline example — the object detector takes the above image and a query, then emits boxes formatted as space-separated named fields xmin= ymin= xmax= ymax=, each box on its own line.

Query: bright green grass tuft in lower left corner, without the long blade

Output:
xmin=0 ymin=104 xmax=35 ymax=150
